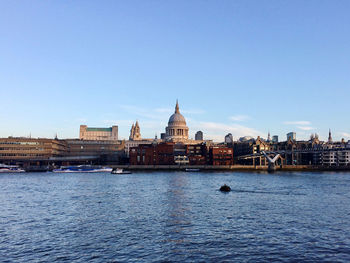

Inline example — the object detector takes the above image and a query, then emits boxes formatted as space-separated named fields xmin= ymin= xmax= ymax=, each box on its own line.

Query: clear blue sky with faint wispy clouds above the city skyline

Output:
xmin=0 ymin=0 xmax=350 ymax=140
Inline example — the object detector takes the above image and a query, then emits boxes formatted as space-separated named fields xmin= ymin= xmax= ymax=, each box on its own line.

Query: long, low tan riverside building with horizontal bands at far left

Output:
xmin=0 ymin=137 xmax=124 ymax=166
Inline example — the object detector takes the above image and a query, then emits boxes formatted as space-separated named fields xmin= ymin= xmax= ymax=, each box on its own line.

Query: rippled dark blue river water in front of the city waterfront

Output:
xmin=0 ymin=172 xmax=350 ymax=262
